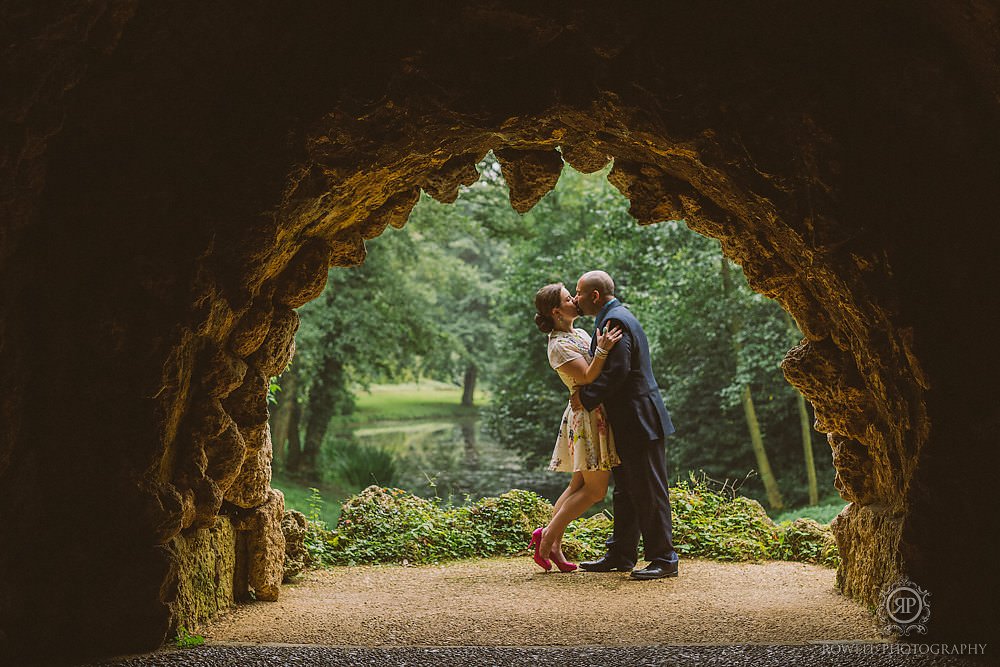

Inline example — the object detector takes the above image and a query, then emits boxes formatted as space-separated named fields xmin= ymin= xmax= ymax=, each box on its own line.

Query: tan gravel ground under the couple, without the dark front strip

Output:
xmin=201 ymin=557 xmax=879 ymax=646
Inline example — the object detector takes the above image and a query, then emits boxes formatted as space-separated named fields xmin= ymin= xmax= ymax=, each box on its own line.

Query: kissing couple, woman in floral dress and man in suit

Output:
xmin=530 ymin=271 xmax=678 ymax=580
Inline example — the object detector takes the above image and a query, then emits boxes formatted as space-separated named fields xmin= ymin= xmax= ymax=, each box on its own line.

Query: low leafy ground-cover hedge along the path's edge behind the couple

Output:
xmin=306 ymin=481 xmax=838 ymax=566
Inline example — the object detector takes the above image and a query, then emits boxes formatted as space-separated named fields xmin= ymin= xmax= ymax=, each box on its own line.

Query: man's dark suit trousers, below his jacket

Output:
xmin=606 ymin=438 xmax=677 ymax=565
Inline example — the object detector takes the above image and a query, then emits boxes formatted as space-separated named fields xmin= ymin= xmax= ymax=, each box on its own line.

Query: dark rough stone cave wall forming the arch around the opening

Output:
xmin=0 ymin=2 xmax=1000 ymax=664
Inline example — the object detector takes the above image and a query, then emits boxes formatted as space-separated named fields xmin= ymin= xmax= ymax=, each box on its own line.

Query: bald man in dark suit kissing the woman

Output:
xmin=571 ymin=271 xmax=678 ymax=580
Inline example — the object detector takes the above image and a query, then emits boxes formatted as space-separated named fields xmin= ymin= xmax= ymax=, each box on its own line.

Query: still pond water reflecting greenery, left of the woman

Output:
xmin=354 ymin=419 xmax=569 ymax=503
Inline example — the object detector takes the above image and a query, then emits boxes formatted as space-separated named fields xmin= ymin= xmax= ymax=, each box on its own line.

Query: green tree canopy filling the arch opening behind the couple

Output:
xmin=276 ymin=156 xmax=833 ymax=506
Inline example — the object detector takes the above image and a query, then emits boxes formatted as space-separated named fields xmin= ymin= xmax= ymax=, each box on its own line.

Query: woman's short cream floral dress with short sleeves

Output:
xmin=549 ymin=329 xmax=621 ymax=472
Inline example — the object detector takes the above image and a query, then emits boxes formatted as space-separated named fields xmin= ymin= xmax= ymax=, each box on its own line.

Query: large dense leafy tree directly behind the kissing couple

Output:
xmin=486 ymin=158 xmax=832 ymax=506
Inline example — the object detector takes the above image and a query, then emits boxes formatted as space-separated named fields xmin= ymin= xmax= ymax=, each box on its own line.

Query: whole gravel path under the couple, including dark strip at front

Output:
xmin=80 ymin=557 xmax=982 ymax=667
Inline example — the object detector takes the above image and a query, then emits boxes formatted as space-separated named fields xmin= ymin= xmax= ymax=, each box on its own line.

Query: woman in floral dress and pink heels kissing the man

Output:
xmin=530 ymin=283 xmax=621 ymax=572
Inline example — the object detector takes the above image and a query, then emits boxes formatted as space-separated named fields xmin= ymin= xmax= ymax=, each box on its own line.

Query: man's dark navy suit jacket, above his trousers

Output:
xmin=580 ymin=303 xmax=674 ymax=447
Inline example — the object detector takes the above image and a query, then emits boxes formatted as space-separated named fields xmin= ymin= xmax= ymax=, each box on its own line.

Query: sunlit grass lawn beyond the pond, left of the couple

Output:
xmin=351 ymin=380 xmax=488 ymax=424
